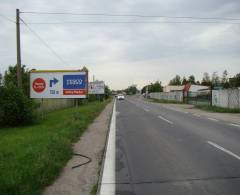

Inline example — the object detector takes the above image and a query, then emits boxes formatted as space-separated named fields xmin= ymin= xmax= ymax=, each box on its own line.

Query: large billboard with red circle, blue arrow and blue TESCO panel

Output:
xmin=30 ymin=70 xmax=88 ymax=98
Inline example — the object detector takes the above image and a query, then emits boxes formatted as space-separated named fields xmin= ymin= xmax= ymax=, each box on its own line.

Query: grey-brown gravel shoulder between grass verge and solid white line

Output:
xmin=43 ymin=102 xmax=113 ymax=195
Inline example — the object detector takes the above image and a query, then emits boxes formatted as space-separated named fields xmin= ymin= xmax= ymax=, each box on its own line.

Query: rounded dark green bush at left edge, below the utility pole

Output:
xmin=0 ymin=84 xmax=34 ymax=126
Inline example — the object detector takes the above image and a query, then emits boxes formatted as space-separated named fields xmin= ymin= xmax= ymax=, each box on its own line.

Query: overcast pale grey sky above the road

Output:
xmin=0 ymin=0 xmax=240 ymax=89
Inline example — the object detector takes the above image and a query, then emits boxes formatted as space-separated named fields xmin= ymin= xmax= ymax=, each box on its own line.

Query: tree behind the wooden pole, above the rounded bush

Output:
xmin=4 ymin=65 xmax=30 ymax=97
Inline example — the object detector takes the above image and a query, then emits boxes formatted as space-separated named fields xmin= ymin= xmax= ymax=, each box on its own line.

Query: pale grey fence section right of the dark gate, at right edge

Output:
xmin=212 ymin=89 xmax=240 ymax=108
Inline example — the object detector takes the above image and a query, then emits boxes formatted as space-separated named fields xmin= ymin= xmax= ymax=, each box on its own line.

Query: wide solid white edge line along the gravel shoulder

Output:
xmin=99 ymin=101 xmax=116 ymax=195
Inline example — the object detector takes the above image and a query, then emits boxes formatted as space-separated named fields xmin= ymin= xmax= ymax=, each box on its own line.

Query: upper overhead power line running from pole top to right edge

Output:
xmin=21 ymin=11 xmax=240 ymax=20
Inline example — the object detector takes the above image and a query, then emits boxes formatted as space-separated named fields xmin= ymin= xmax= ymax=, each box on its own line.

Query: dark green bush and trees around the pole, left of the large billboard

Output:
xmin=0 ymin=66 xmax=37 ymax=126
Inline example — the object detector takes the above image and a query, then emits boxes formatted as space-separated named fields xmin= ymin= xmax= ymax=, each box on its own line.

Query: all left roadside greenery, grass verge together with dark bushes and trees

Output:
xmin=0 ymin=65 xmax=111 ymax=195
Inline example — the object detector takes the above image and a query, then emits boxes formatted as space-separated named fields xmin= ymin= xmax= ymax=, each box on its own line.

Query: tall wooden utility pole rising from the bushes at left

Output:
xmin=16 ymin=9 xmax=22 ymax=88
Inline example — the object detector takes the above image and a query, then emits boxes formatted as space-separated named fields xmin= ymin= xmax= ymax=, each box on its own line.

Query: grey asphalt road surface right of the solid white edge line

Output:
xmin=115 ymin=98 xmax=240 ymax=195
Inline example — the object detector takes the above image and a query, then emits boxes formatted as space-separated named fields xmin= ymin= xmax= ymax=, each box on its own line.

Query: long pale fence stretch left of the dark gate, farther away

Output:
xmin=149 ymin=91 xmax=183 ymax=102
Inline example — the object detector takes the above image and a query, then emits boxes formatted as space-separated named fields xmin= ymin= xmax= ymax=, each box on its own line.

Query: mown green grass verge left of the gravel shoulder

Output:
xmin=0 ymin=101 xmax=109 ymax=195
